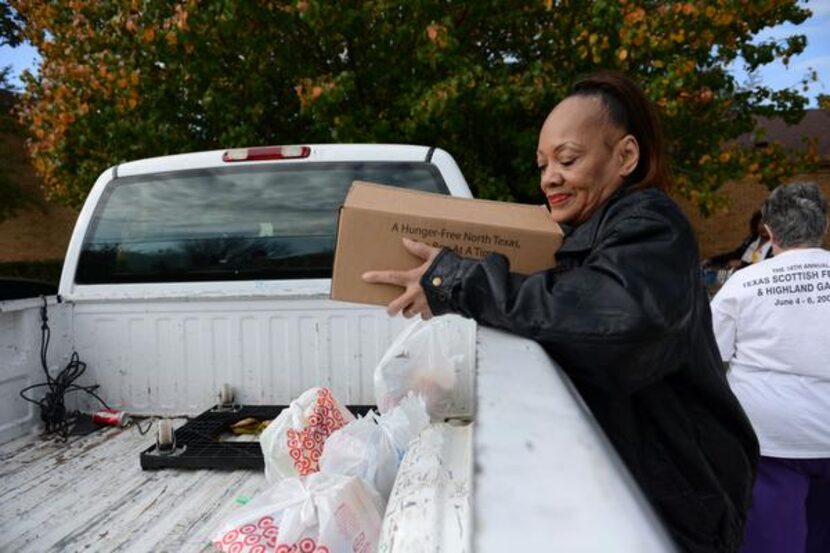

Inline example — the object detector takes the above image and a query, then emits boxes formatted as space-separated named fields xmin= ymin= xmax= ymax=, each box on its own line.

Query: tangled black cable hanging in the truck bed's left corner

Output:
xmin=20 ymin=296 xmax=109 ymax=440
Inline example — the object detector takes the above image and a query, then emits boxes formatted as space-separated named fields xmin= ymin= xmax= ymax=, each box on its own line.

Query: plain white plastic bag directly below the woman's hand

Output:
xmin=374 ymin=317 xmax=460 ymax=420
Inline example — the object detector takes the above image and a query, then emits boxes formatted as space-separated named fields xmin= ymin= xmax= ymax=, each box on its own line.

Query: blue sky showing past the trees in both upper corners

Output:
xmin=0 ymin=0 xmax=830 ymax=107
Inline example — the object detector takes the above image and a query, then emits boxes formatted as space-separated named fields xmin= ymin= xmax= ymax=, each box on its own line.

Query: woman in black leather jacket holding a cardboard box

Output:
xmin=364 ymin=73 xmax=758 ymax=552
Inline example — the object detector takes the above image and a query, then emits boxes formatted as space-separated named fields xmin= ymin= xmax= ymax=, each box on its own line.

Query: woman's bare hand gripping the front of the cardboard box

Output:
xmin=362 ymin=238 xmax=441 ymax=320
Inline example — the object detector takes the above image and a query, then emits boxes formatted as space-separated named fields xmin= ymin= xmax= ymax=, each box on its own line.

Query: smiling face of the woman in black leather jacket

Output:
xmin=536 ymin=96 xmax=639 ymax=224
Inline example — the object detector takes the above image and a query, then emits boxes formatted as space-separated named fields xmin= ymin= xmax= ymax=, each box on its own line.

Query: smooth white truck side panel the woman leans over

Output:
xmin=474 ymin=328 xmax=674 ymax=553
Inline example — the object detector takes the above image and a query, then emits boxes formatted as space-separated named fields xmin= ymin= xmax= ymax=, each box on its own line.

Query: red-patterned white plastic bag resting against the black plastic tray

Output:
xmin=259 ymin=388 xmax=354 ymax=484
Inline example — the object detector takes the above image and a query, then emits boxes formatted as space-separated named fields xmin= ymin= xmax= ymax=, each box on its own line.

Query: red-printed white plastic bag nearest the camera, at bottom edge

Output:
xmin=211 ymin=473 xmax=383 ymax=553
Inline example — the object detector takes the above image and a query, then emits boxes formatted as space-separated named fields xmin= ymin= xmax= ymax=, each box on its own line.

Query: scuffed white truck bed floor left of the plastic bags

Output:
xmin=0 ymin=419 xmax=266 ymax=552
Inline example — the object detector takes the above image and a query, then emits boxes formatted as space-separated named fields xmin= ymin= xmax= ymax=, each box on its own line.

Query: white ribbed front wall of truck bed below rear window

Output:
xmin=68 ymin=298 xmax=404 ymax=415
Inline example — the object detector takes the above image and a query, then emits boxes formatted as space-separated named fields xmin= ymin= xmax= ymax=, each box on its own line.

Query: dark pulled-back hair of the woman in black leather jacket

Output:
xmin=570 ymin=71 xmax=672 ymax=190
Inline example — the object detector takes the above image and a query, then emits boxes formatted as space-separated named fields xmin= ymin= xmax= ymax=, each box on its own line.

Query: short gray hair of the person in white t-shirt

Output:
xmin=761 ymin=182 xmax=827 ymax=250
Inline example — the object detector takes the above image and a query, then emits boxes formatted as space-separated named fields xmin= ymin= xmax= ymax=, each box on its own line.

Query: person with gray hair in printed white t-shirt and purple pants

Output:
xmin=711 ymin=183 xmax=830 ymax=553
